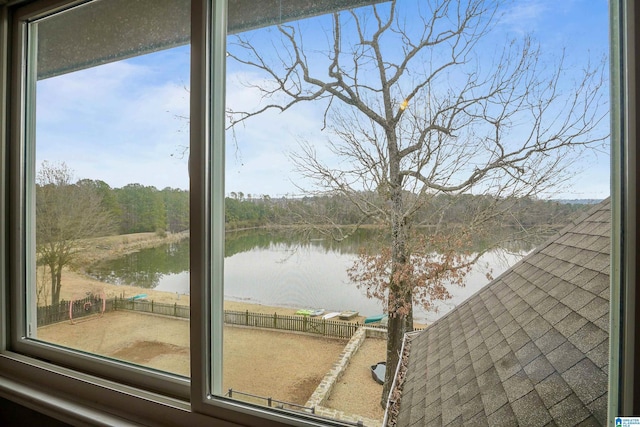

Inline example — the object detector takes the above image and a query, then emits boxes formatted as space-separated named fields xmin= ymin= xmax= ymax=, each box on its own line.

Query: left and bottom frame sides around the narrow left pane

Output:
xmin=8 ymin=1 xmax=190 ymax=398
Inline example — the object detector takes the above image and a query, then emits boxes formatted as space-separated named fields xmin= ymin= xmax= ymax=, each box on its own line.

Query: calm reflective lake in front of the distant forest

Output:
xmin=89 ymin=231 xmax=524 ymax=323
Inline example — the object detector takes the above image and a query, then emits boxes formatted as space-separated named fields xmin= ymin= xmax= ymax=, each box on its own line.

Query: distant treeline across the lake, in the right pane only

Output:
xmin=225 ymin=193 xmax=590 ymax=229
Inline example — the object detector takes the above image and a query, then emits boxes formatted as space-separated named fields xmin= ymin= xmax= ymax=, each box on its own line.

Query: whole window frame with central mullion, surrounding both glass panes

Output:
xmin=0 ymin=0 xmax=640 ymax=426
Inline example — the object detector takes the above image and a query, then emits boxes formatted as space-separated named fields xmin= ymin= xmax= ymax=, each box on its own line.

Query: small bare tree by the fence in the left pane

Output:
xmin=36 ymin=161 xmax=114 ymax=305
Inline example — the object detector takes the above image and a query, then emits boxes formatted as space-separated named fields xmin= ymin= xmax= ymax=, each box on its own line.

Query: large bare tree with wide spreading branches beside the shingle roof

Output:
xmin=227 ymin=0 xmax=608 ymax=405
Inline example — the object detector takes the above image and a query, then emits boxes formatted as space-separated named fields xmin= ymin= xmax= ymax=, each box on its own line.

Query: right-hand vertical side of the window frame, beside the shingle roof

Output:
xmin=608 ymin=0 xmax=640 ymax=422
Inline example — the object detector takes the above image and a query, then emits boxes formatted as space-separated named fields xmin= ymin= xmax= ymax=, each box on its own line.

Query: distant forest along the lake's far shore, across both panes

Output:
xmin=72 ymin=180 xmax=589 ymax=234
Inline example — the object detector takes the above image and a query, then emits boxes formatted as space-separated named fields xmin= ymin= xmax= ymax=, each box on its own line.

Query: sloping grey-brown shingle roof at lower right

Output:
xmin=396 ymin=200 xmax=611 ymax=427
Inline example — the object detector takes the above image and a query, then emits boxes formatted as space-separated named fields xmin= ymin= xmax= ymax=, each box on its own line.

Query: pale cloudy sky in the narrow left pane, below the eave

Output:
xmin=36 ymin=47 xmax=189 ymax=188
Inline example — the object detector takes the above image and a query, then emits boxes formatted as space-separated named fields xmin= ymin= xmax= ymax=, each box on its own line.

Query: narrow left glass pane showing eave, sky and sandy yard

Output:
xmin=27 ymin=1 xmax=190 ymax=376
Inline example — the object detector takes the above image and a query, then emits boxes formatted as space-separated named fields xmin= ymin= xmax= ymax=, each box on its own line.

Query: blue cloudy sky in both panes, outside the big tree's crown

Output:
xmin=35 ymin=0 xmax=609 ymax=199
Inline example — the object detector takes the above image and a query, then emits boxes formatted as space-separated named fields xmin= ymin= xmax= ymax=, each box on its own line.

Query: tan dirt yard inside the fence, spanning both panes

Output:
xmin=38 ymin=312 xmax=346 ymax=405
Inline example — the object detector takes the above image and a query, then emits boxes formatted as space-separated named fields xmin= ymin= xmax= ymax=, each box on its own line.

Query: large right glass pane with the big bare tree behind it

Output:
xmin=223 ymin=0 xmax=610 ymax=425
